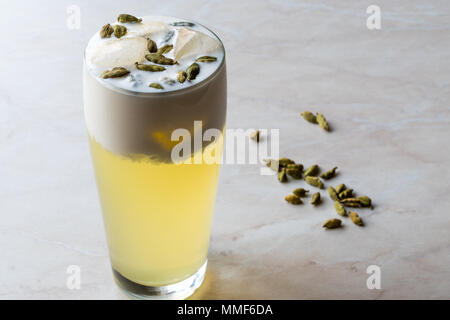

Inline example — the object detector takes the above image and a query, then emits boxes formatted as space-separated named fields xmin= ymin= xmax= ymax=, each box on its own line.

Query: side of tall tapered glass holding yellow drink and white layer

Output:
xmin=84 ymin=20 xmax=227 ymax=299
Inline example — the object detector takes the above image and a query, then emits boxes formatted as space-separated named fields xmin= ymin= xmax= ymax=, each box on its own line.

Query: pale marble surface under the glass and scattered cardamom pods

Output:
xmin=0 ymin=0 xmax=450 ymax=299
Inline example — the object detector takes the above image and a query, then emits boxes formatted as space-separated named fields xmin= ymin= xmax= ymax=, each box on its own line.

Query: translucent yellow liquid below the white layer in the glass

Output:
xmin=89 ymin=138 xmax=223 ymax=286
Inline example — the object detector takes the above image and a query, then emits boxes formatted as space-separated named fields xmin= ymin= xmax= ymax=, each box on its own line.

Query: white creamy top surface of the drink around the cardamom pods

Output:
xmin=85 ymin=16 xmax=224 ymax=92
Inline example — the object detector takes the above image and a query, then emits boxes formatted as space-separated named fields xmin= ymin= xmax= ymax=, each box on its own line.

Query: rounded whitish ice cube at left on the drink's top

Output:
xmin=86 ymin=38 xmax=147 ymax=70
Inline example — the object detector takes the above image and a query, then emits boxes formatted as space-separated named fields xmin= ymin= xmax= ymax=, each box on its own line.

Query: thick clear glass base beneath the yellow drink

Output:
xmin=113 ymin=261 xmax=208 ymax=300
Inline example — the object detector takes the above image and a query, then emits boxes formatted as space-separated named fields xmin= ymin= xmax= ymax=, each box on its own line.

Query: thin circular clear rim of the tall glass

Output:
xmin=83 ymin=16 xmax=226 ymax=97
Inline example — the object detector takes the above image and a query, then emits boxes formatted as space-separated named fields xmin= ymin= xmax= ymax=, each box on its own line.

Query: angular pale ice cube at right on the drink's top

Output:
xmin=175 ymin=28 xmax=220 ymax=60
